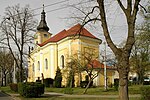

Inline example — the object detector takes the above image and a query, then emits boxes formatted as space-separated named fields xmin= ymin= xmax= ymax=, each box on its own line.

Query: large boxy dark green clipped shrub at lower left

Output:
xmin=18 ymin=82 xmax=44 ymax=97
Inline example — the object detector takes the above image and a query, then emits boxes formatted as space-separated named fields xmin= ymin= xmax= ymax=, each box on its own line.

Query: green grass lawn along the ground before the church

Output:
xmin=0 ymin=85 xmax=141 ymax=100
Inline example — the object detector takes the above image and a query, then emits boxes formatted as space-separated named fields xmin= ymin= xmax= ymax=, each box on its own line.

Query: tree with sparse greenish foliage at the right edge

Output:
xmin=130 ymin=2 xmax=150 ymax=84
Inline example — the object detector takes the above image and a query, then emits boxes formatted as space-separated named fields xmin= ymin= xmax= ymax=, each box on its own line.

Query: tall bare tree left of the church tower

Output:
xmin=1 ymin=5 xmax=37 ymax=82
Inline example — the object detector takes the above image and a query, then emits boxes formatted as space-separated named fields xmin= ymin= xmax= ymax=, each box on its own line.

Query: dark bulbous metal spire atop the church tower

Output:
xmin=37 ymin=4 xmax=49 ymax=32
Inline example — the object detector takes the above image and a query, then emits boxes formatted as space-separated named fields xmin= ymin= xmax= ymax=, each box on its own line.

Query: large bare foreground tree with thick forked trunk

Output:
xmin=70 ymin=0 xmax=143 ymax=100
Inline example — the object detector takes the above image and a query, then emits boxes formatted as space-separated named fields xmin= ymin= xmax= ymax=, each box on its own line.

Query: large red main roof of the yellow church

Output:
xmin=39 ymin=24 xmax=99 ymax=46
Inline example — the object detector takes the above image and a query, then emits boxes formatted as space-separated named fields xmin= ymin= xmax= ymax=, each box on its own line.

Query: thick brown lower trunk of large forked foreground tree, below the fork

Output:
xmin=117 ymin=51 xmax=129 ymax=100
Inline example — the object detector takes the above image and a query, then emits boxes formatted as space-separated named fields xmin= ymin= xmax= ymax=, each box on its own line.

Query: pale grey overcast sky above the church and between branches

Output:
xmin=0 ymin=0 xmax=148 ymax=55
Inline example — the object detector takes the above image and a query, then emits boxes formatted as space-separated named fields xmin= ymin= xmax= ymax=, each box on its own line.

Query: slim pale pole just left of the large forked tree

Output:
xmin=104 ymin=42 xmax=107 ymax=91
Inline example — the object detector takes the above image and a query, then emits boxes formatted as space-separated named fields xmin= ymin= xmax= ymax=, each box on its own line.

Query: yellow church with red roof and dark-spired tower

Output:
xmin=28 ymin=10 xmax=117 ymax=85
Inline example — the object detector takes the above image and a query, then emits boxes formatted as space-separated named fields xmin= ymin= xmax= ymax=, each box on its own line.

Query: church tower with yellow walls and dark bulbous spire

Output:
xmin=34 ymin=5 xmax=52 ymax=44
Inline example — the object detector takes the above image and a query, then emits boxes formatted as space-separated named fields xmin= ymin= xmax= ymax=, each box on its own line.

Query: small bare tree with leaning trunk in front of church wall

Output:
xmin=68 ymin=48 xmax=101 ymax=94
